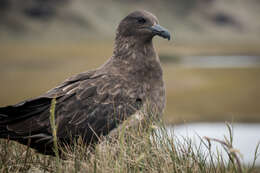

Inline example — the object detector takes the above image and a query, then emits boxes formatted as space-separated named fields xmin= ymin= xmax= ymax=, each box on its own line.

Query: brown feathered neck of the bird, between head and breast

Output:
xmin=109 ymin=37 xmax=162 ymax=79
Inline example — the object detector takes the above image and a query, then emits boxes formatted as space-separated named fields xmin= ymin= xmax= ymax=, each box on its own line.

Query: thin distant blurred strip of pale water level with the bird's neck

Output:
xmin=178 ymin=55 xmax=260 ymax=68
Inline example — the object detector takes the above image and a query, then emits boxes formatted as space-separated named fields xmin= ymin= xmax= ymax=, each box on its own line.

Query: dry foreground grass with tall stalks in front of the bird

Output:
xmin=0 ymin=103 xmax=258 ymax=173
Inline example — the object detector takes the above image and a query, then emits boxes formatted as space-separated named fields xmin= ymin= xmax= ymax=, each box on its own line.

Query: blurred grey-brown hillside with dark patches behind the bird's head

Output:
xmin=0 ymin=0 xmax=260 ymax=42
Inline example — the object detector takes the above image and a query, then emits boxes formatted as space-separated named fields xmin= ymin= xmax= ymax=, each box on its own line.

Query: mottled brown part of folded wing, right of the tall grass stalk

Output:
xmin=53 ymin=74 xmax=142 ymax=141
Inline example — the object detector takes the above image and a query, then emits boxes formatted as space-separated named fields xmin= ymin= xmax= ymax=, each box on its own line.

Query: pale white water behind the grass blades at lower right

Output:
xmin=167 ymin=123 xmax=260 ymax=166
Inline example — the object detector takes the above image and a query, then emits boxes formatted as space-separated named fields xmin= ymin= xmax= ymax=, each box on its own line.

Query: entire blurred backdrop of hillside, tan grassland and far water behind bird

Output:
xmin=0 ymin=0 xmax=260 ymax=124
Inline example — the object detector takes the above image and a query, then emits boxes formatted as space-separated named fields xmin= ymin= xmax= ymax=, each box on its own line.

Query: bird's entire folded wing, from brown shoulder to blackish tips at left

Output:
xmin=0 ymin=72 xmax=142 ymax=146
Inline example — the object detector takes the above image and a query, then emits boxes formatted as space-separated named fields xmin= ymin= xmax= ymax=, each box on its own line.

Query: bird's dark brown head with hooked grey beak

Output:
xmin=117 ymin=10 xmax=171 ymax=41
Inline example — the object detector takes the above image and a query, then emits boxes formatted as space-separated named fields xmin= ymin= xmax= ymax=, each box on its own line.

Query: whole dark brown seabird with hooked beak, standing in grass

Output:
xmin=0 ymin=10 xmax=171 ymax=155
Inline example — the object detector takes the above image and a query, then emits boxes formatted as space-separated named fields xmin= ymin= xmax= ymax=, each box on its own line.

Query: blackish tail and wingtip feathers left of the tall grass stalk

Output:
xmin=0 ymin=97 xmax=53 ymax=155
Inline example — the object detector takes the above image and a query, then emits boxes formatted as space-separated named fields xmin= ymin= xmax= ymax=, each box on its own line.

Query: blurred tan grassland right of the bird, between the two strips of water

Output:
xmin=164 ymin=65 xmax=260 ymax=124
